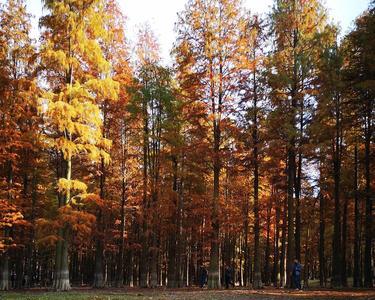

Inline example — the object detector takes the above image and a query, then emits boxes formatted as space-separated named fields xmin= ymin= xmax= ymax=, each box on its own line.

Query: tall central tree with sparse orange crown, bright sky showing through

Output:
xmin=176 ymin=0 xmax=247 ymax=288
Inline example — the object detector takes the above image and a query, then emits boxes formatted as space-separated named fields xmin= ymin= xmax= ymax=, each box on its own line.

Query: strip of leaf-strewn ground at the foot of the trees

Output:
xmin=0 ymin=288 xmax=375 ymax=300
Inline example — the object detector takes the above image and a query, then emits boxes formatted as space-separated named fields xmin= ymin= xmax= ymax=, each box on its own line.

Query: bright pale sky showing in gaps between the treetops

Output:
xmin=0 ymin=0 xmax=369 ymax=64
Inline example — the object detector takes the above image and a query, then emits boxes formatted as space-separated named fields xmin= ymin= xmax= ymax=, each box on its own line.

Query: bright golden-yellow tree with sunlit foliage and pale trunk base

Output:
xmin=40 ymin=0 xmax=117 ymax=290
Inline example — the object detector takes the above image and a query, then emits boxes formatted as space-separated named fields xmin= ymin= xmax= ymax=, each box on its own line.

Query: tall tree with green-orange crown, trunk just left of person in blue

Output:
xmin=268 ymin=0 xmax=327 ymax=287
